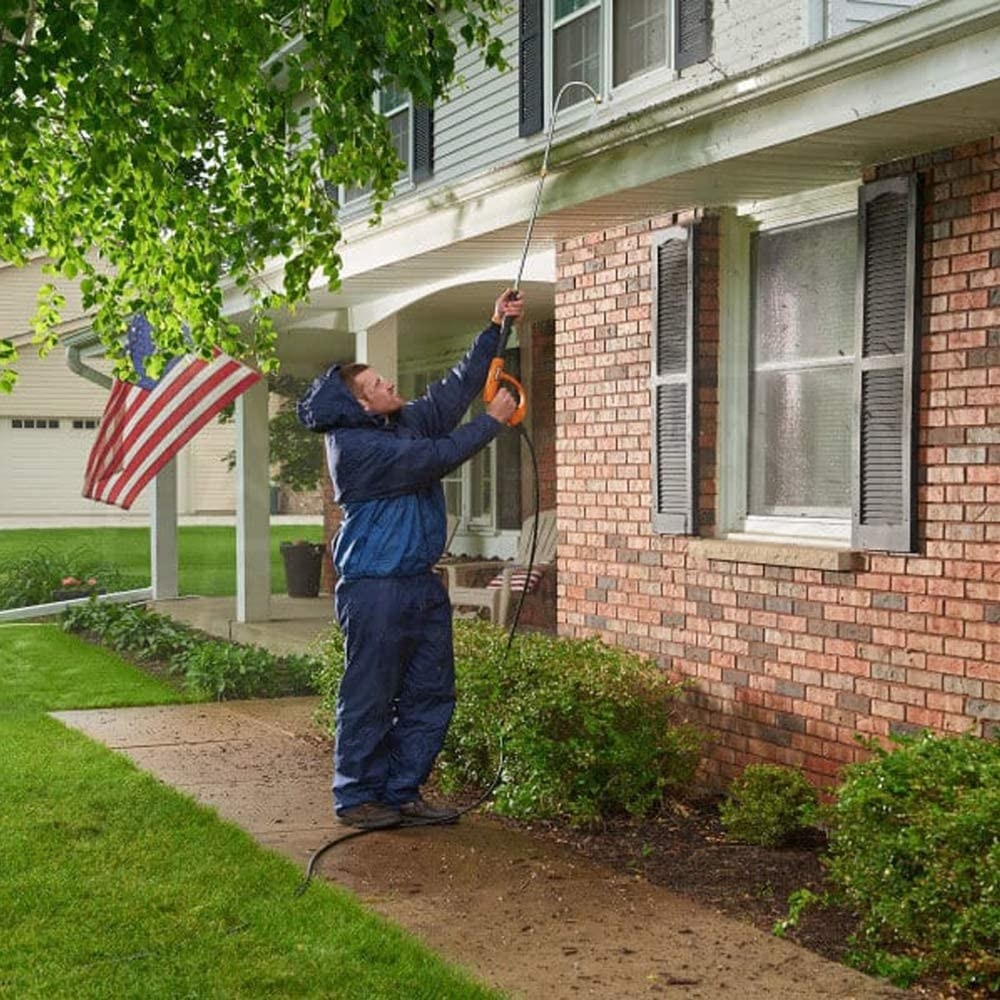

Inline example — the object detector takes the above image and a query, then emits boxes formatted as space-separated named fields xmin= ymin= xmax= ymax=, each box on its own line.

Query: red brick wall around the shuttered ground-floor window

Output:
xmin=555 ymin=137 xmax=1000 ymax=782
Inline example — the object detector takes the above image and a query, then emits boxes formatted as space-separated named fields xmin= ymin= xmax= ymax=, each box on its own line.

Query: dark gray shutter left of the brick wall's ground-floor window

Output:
xmin=651 ymin=226 xmax=697 ymax=535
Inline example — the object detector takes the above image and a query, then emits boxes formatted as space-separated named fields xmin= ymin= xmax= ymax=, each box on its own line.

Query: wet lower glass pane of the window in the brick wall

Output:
xmin=750 ymin=364 xmax=854 ymax=517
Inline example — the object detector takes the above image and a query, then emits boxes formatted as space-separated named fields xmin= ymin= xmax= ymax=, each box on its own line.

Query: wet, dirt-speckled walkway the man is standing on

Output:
xmin=54 ymin=699 xmax=906 ymax=1000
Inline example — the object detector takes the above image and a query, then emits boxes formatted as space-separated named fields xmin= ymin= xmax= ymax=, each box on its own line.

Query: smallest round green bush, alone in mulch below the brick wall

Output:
xmin=719 ymin=764 xmax=817 ymax=847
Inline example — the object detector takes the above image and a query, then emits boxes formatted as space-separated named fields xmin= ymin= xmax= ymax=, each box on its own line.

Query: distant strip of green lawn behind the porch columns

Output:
xmin=0 ymin=524 xmax=323 ymax=597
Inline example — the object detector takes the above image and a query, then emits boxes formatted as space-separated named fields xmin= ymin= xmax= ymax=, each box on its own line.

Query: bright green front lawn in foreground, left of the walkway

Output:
xmin=0 ymin=624 xmax=496 ymax=1000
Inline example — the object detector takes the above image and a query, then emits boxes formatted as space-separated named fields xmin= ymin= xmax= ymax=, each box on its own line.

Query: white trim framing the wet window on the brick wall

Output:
xmin=718 ymin=181 xmax=860 ymax=548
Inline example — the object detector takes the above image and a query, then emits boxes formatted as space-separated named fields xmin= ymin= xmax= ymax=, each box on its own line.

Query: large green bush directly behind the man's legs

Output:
xmin=319 ymin=621 xmax=703 ymax=823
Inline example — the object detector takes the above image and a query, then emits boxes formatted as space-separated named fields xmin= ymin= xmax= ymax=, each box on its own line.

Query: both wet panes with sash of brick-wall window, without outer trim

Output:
xmin=747 ymin=215 xmax=857 ymax=525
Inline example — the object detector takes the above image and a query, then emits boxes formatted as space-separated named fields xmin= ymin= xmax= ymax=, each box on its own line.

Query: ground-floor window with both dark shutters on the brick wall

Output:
xmin=650 ymin=175 xmax=920 ymax=552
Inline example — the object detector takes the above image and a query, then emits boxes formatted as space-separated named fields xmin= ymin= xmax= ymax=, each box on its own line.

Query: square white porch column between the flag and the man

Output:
xmin=236 ymin=378 xmax=271 ymax=622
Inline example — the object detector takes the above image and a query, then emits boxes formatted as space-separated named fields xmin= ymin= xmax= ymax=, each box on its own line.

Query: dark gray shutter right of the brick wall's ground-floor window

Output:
xmin=852 ymin=174 xmax=920 ymax=552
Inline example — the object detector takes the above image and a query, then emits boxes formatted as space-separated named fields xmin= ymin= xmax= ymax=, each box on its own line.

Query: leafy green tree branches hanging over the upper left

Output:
xmin=0 ymin=0 xmax=505 ymax=391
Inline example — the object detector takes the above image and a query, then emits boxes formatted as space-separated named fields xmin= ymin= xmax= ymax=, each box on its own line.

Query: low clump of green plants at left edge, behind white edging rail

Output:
xmin=0 ymin=546 xmax=133 ymax=611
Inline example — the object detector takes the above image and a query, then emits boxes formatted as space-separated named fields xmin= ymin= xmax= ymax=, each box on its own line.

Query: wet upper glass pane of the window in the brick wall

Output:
xmin=754 ymin=217 xmax=857 ymax=364
